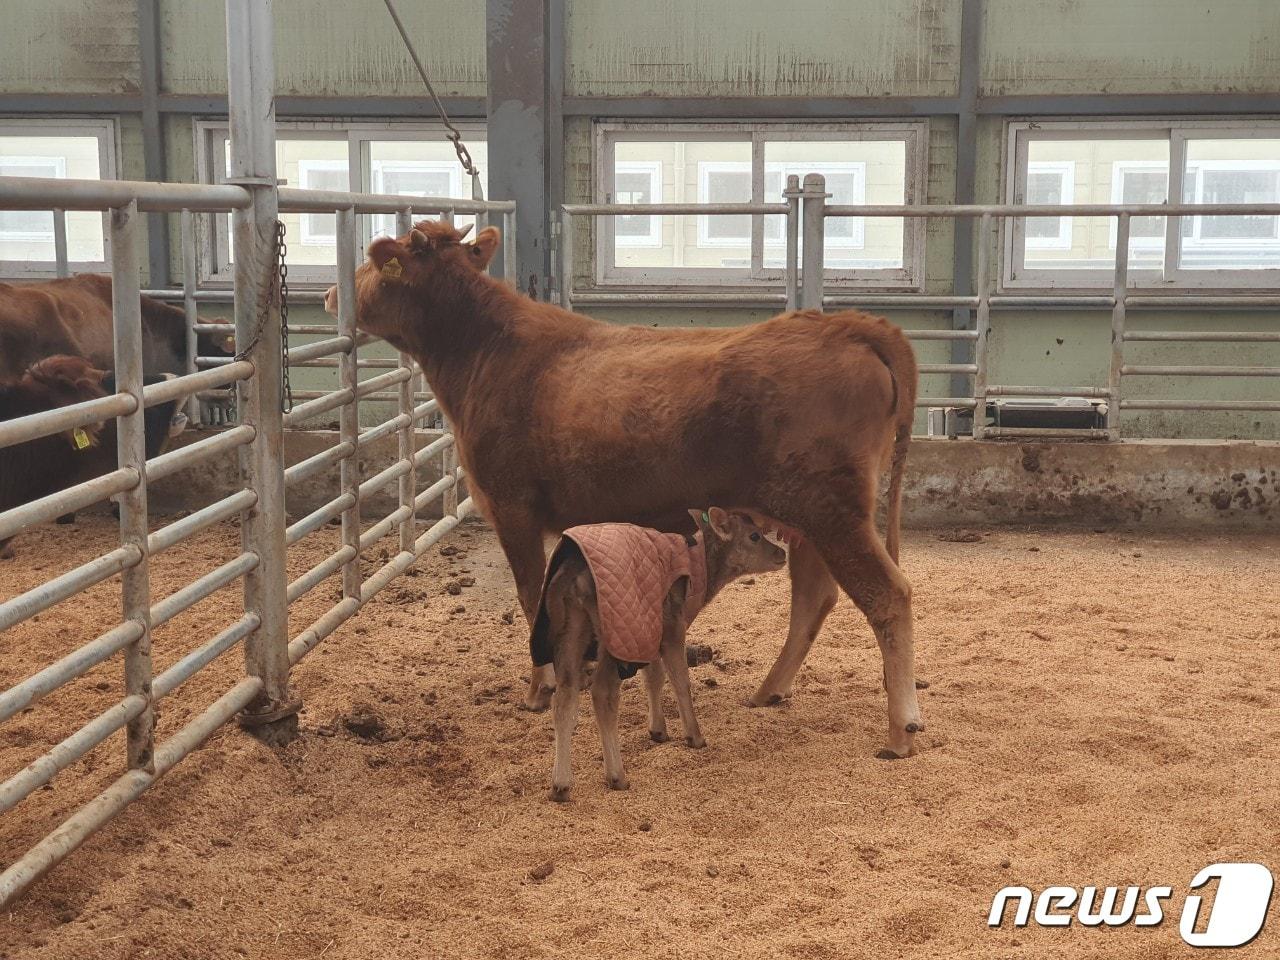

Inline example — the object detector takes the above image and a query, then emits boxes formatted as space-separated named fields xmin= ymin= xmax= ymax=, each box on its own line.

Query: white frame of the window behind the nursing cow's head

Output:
xmin=192 ymin=118 xmax=488 ymax=289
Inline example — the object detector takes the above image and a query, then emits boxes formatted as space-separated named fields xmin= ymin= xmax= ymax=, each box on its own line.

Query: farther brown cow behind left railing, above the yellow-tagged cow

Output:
xmin=0 ymin=274 xmax=236 ymax=378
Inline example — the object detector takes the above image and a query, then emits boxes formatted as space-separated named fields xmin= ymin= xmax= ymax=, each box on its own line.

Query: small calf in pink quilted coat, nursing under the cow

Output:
xmin=530 ymin=507 xmax=787 ymax=801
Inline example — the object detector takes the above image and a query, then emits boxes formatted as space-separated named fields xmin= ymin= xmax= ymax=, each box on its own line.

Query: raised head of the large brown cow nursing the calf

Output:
xmin=325 ymin=220 xmax=500 ymax=349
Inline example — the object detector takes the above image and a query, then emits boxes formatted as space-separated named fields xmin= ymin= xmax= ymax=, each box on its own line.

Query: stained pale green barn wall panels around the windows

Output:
xmin=0 ymin=0 xmax=1280 ymax=439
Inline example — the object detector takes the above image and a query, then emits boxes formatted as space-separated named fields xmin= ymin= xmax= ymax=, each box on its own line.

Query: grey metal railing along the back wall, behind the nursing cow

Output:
xmin=557 ymin=174 xmax=1280 ymax=440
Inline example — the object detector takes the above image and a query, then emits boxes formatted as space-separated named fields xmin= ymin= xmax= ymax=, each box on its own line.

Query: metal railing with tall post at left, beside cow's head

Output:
xmin=0 ymin=0 xmax=516 ymax=905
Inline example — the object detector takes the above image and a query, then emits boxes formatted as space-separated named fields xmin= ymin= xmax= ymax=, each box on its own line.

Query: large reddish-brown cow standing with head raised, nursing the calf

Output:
xmin=326 ymin=221 xmax=923 ymax=758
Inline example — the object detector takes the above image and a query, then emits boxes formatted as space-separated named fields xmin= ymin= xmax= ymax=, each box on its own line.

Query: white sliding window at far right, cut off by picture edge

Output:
xmin=1004 ymin=119 xmax=1280 ymax=289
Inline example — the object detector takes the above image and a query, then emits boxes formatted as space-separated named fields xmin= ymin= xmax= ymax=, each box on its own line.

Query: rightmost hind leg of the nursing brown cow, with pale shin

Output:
xmin=818 ymin=520 xmax=924 ymax=759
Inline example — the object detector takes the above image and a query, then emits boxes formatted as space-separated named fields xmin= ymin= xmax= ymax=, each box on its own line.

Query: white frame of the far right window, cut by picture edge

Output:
xmin=998 ymin=116 xmax=1280 ymax=293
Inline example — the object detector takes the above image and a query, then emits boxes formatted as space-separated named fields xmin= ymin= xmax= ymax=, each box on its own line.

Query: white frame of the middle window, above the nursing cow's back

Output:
xmin=588 ymin=119 xmax=929 ymax=292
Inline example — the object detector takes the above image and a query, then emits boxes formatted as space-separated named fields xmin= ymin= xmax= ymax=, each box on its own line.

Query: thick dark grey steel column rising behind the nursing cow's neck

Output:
xmin=486 ymin=0 xmax=563 ymax=300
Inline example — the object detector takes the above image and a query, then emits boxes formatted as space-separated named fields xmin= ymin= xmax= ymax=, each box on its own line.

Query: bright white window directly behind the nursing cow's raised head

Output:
xmin=196 ymin=122 xmax=488 ymax=285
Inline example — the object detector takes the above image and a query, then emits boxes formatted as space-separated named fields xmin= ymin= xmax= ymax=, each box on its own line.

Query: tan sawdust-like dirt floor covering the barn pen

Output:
xmin=0 ymin=517 xmax=1280 ymax=960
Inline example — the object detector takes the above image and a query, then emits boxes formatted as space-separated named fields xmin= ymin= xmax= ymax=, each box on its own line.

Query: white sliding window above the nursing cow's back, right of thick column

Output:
xmin=595 ymin=122 xmax=928 ymax=289
